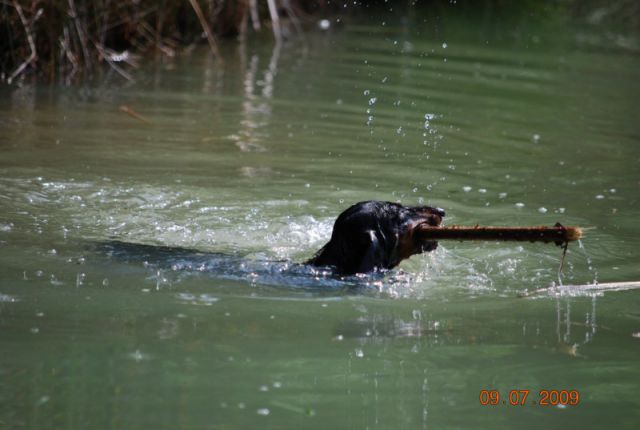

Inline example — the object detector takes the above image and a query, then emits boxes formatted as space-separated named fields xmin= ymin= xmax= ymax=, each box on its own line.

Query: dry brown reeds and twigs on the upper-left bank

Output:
xmin=0 ymin=0 xmax=327 ymax=84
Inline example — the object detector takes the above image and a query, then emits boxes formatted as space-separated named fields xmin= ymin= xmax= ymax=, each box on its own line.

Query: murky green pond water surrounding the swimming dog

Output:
xmin=0 ymin=8 xmax=640 ymax=429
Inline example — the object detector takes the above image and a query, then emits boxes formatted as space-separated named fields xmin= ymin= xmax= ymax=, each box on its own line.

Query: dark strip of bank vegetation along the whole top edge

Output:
xmin=0 ymin=0 xmax=640 ymax=85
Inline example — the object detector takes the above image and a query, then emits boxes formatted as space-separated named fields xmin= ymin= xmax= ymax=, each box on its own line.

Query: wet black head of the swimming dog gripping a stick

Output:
xmin=306 ymin=201 xmax=445 ymax=275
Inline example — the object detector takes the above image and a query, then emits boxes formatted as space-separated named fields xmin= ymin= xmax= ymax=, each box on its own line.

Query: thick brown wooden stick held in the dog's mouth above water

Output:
xmin=417 ymin=224 xmax=582 ymax=245
